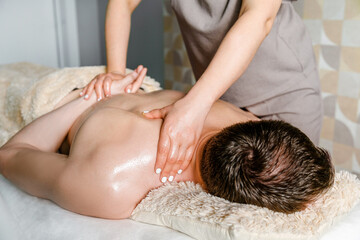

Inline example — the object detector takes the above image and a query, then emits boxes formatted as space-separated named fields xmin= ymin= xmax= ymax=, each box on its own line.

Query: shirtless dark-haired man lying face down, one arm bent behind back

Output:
xmin=0 ymin=70 xmax=334 ymax=219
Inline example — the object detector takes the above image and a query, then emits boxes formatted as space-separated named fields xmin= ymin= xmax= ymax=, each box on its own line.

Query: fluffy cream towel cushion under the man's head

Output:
xmin=132 ymin=171 xmax=360 ymax=240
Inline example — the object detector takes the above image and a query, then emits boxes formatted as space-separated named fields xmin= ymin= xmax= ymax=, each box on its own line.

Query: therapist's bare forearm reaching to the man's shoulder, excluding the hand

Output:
xmin=187 ymin=2 xmax=278 ymax=105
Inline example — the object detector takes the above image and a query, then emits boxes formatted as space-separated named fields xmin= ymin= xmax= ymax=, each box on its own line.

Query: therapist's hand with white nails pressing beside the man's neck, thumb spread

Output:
xmin=144 ymin=98 xmax=211 ymax=183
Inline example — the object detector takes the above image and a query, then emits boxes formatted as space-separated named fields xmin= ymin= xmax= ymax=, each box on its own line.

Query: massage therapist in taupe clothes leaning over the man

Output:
xmin=81 ymin=0 xmax=322 ymax=182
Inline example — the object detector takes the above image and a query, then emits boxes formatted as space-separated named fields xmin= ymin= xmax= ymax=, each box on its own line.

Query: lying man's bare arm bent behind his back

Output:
xmin=0 ymin=69 xmax=146 ymax=200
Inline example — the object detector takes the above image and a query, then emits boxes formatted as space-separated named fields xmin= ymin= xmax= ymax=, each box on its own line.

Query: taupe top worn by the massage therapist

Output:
xmin=171 ymin=0 xmax=319 ymax=107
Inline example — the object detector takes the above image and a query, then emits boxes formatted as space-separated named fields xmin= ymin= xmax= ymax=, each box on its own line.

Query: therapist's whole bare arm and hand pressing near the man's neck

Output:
xmin=145 ymin=0 xmax=281 ymax=181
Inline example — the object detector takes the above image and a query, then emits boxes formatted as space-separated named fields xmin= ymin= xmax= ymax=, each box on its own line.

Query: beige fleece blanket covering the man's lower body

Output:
xmin=0 ymin=62 xmax=161 ymax=146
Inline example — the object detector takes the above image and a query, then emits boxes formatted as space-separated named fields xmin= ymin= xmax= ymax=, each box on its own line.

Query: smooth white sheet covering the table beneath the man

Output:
xmin=0 ymin=175 xmax=360 ymax=240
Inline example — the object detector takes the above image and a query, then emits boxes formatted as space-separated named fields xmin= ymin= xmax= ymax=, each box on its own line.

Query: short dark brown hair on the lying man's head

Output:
xmin=200 ymin=120 xmax=335 ymax=213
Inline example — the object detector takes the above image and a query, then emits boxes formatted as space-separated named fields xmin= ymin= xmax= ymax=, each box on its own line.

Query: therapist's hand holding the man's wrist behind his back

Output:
xmin=80 ymin=65 xmax=144 ymax=101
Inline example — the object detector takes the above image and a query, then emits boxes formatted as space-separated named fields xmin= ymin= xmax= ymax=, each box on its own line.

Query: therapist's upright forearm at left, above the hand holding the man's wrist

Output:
xmin=105 ymin=0 xmax=140 ymax=75
